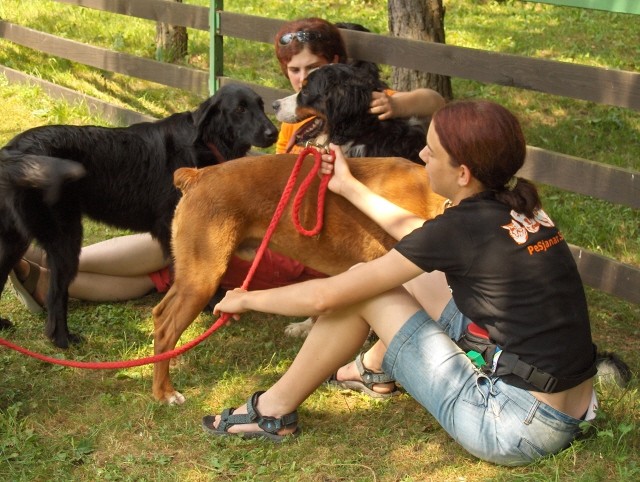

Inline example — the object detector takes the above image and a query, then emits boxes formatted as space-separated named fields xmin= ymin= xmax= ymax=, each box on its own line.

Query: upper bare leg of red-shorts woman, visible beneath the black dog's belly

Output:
xmin=25 ymin=233 xmax=169 ymax=276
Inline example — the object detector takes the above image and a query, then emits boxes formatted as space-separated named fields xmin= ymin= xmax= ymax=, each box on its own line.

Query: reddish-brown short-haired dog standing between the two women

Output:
xmin=153 ymin=154 xmax=444 ymax=404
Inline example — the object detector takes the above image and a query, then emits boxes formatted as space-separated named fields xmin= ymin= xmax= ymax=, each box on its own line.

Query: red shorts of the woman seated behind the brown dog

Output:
xmin=149 ymin=249 xmax=327 ymax=293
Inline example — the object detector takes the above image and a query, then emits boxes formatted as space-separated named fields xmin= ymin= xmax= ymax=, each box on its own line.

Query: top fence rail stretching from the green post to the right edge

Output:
xmin=219 ymin=12 xmax=640 ymax=110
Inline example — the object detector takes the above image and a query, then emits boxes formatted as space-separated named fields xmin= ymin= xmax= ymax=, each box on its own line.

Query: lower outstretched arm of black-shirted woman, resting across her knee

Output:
xmin=213 ymin=250 xmax=422 ymax=319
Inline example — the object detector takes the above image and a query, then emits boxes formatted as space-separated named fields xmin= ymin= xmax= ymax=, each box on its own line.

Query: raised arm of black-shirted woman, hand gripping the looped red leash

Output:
xmin=322 ymin=144 xmax=425 ymax=240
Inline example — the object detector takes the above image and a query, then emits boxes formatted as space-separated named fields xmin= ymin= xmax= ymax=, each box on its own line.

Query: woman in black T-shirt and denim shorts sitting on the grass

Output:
xmin=203 ymin=101 xmax=596 ymax=465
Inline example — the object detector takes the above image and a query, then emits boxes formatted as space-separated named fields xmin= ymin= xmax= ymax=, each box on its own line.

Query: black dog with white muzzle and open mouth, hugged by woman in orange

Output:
xmin=273 ymin=64 xmax=426 ymax=164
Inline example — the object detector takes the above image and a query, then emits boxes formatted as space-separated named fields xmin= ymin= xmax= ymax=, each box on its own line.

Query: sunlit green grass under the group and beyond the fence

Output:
xmin=0 ymin=0 xmax=640 ymax=481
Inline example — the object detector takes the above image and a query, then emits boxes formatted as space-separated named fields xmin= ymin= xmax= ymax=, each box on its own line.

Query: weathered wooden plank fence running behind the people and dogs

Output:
xmin=0 ymin=0 xmax=640 ymax=303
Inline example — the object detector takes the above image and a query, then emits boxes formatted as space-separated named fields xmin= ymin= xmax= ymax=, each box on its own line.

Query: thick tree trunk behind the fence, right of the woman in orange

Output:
xmin=388 ymin=0 xmax=453 ymax=100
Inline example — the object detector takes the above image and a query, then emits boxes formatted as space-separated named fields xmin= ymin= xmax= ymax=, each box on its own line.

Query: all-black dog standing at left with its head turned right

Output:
xmin=0 ymin=84 xmax=278 ymax=348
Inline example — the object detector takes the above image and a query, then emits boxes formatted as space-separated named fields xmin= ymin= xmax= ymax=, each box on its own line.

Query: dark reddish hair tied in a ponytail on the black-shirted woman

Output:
xmin=432 ymin=100 xmax=541 ymax=216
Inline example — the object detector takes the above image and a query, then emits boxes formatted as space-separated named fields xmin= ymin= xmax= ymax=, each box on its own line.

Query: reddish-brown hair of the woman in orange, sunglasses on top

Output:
xmin=274 ymin=17 xmax=347 ymax=77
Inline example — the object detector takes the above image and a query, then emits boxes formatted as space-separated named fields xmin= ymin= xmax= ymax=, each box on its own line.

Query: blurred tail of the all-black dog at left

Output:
xmin=0 ymin=149 xmax=86 ymax=204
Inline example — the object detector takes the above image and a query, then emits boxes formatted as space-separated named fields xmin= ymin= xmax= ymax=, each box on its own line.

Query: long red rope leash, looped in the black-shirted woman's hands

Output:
xmin=0 ymin=147 xmax=335 ymax=370
